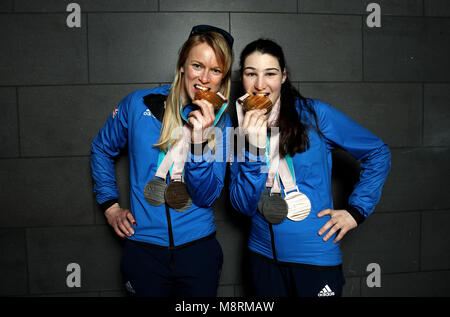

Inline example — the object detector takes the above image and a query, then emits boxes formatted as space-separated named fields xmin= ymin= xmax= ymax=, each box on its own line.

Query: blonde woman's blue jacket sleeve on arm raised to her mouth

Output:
xmin=184 ymin=114 xmax=231 ymax=207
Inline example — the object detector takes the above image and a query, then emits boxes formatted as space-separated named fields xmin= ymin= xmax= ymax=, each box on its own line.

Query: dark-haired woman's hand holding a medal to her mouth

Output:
xmin=242 ymin=109 xmax=267 ymax=148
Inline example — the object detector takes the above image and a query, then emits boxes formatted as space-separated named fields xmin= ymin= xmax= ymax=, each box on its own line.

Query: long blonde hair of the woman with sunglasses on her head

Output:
xmin=155 ymin=32 xmax=233 ymax=151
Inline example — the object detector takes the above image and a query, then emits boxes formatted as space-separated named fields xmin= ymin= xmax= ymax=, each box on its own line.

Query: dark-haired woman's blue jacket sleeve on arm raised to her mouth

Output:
xmin=230 ymin=136 xmax=268 ymax=217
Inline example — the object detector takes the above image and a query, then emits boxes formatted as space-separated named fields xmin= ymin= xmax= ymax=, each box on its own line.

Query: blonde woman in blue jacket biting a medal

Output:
xmin=91 ymin=25 xmax=233 ymax=297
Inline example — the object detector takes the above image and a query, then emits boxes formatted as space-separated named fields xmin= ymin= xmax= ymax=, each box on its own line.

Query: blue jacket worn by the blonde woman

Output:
xmin=91 ymin=85 xmax=231 ymax=247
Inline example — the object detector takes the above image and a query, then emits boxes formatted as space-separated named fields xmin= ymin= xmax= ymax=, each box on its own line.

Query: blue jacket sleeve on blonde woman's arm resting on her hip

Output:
xmin=90 ymin=94 xmax=132 ymax=209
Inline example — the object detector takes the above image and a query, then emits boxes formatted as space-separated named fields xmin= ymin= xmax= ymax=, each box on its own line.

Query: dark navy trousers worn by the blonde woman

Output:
xmin=121 ymin=236 xmax=223 ymax=297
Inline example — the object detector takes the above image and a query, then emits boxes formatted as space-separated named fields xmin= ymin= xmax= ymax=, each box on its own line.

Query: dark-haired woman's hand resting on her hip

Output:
xmin=317 ymin=209 xmax=358 ymax=243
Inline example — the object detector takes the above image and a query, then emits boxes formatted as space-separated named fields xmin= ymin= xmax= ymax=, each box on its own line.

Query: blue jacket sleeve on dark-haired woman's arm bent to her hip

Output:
xmin=314 ymin=101 xmax=391 ymax=223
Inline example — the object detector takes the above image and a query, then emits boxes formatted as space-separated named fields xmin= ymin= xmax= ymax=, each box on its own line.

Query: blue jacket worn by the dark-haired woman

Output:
xmin=230 ymin=99 xmax=390 ymax=266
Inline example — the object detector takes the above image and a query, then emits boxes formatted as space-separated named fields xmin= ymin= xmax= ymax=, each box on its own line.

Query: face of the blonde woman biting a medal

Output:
xmin=180 ymin=43 xmax=224 ymax=105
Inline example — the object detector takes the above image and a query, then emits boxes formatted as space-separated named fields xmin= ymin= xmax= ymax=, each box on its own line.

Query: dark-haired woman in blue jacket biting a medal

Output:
xmin=230 ymin=39 xmax=390 ymax=297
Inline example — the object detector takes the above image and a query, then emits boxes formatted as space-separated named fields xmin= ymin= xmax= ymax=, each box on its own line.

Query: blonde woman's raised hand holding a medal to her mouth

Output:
xmin=188 ymin=99 xmax=216 ymax=143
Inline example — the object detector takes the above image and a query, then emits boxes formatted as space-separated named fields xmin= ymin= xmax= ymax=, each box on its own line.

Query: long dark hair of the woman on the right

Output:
xmin=240 ymin=39 xmax=320 ymax=157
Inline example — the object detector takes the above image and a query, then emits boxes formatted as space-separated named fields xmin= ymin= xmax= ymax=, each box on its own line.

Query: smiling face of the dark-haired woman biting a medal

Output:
xmin=242 ymin=51 xmax=286 ymax=104
